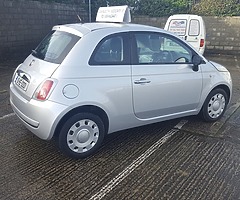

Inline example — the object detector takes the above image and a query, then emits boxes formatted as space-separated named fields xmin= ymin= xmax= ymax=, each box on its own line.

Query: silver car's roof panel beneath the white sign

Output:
xmin=53 ymin=22 xmax=164 ymax=37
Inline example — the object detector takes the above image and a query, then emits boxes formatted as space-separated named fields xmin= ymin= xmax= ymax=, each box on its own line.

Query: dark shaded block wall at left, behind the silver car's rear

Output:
xmin=0 ymin=0 xmax=88 ymax=60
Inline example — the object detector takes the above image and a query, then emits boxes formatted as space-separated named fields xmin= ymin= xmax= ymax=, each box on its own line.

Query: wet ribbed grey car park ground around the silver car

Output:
xmin=0 ymin=55 xmax=240 ymax=200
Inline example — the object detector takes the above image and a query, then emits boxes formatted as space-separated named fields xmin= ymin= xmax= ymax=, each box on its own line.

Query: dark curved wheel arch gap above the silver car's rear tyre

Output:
xmin=53 ymin=105 xmax=109 ymax=137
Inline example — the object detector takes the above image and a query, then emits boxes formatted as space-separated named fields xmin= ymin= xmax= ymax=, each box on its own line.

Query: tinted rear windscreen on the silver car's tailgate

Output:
xmin=32 ymin=31 xmax=80 ymax=64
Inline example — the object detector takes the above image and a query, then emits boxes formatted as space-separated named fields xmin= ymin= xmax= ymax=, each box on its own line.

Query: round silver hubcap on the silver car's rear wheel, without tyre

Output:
xmin=67 ymin=119 xmax=99 ymax=153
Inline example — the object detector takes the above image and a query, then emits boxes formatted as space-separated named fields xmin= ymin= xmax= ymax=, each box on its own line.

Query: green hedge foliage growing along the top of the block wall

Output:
xmin=16 ymin=0 xmax=240 ymax=16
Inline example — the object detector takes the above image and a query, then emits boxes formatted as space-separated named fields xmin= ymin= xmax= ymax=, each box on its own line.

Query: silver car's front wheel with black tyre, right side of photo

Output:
xmin=201 ymin=88 xmax=228 ymax=122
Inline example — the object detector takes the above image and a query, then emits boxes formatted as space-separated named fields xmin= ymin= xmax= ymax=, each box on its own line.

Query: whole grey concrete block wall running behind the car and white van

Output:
xmin=0 ymin=0 xmax=240 ymax=61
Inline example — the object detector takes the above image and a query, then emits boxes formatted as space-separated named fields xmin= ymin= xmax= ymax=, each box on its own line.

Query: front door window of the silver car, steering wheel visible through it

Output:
xmin=135 ymin=32 xmax=192 ymax=64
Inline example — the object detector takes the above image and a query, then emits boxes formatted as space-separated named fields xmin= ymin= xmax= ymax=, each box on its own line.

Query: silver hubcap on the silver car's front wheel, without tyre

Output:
xmin=208 ymin=94 xmax=226 ymax=119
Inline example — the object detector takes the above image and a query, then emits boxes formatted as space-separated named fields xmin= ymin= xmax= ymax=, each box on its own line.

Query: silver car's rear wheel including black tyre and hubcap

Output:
xmin=59 ymin=113 xmax=104 ymax=158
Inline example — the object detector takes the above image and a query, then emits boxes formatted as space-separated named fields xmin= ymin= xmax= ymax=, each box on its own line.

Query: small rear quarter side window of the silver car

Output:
xmin=90 ymin=35 xmax=125 ymax=65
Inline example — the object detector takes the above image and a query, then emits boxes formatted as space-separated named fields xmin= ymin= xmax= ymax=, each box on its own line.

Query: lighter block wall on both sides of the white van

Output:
xmin=132 ymin=16 xmax=240 ymax=55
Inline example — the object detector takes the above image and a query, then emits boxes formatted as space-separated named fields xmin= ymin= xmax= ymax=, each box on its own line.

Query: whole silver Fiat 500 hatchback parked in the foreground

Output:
xmin=10 ymin=7 xmax=232 ymax=158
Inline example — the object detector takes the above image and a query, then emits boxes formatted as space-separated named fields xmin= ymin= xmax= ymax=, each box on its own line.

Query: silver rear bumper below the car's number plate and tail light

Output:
xmin=10 ymin=84 xmax=67 ymax=140
